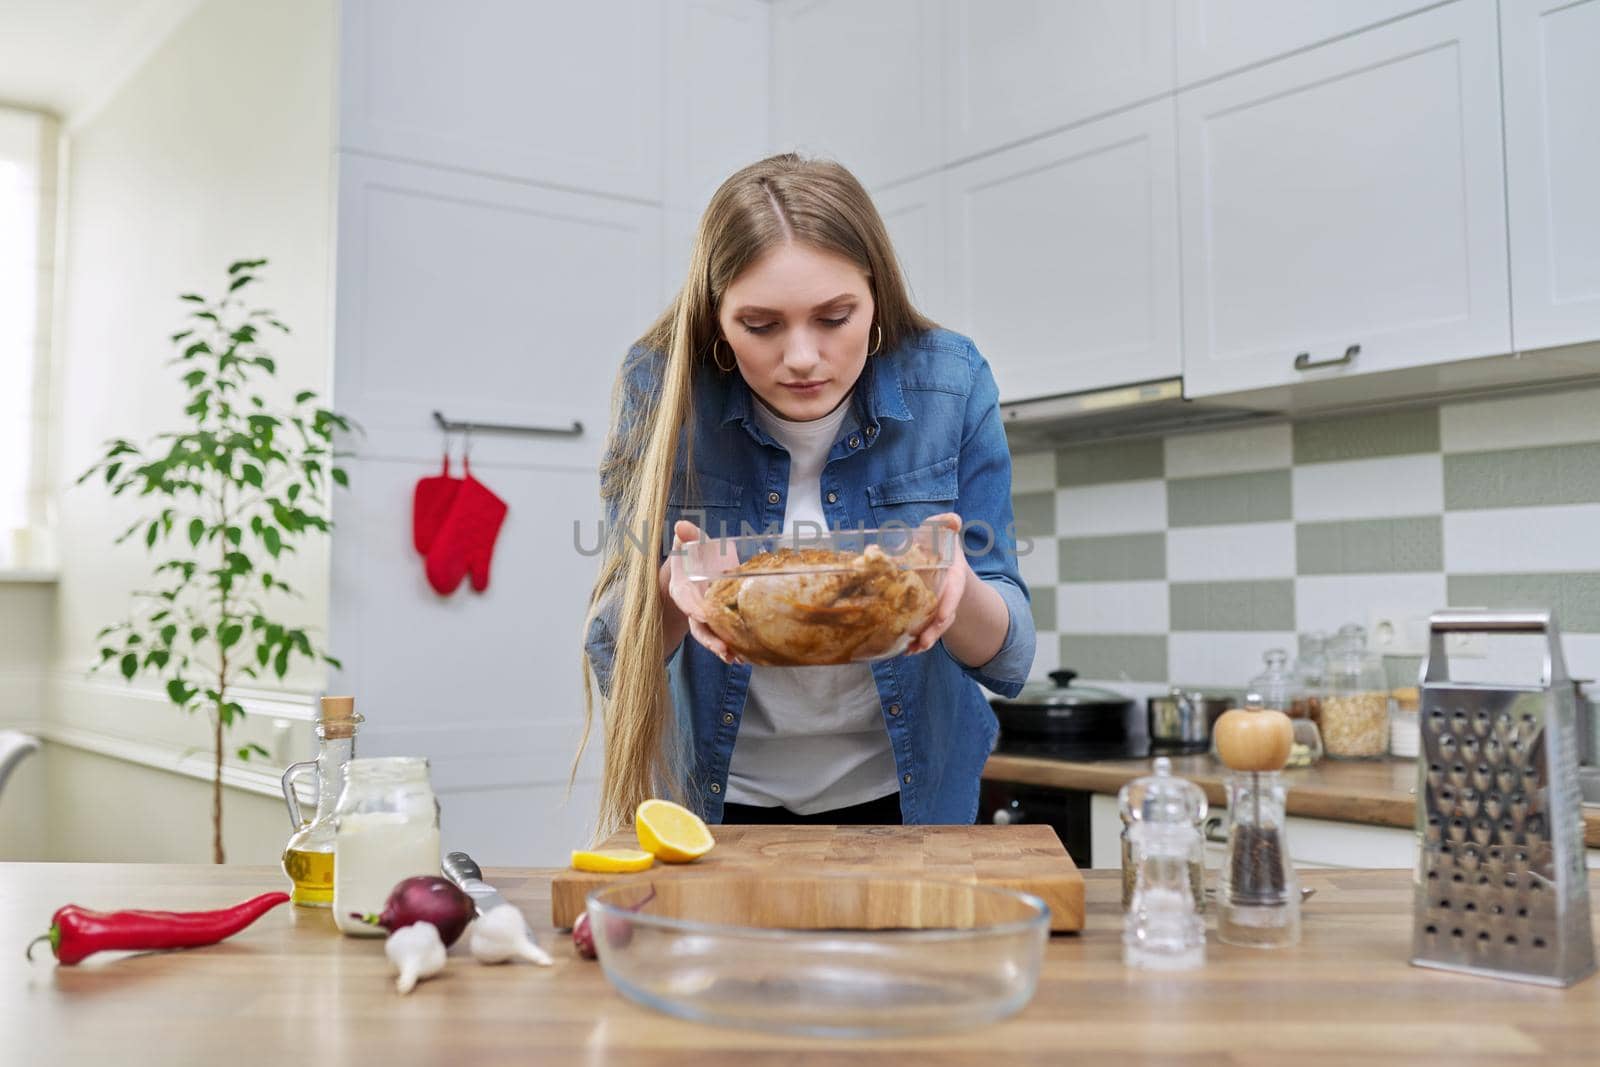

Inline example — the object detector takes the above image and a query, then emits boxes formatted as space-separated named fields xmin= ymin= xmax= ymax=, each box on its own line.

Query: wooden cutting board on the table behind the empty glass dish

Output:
xmin=550 ymin=824 xmax=1083 ymax=933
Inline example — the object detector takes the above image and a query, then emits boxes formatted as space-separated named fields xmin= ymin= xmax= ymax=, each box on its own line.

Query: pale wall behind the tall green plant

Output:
xmin=34 ymin=0 xmax=338 ymax=862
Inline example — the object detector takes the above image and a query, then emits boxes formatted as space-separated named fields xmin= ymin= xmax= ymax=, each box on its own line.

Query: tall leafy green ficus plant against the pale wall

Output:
xmin=78 ymin=259 xmax=350 ymax=864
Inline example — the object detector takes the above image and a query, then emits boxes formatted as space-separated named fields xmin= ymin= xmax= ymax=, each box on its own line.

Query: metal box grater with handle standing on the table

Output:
xmin=1411 ymin=611 xmax=1595 ymax=985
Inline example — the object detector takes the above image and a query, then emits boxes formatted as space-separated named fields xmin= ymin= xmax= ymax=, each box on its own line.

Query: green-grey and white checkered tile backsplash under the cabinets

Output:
xmin=1013 ymin=389 xmax=1600 ymax=686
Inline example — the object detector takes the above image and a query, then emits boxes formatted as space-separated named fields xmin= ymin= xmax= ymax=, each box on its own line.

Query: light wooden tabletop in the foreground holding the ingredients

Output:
xmin=9 ymin=864 xmax=1600 ymax=1067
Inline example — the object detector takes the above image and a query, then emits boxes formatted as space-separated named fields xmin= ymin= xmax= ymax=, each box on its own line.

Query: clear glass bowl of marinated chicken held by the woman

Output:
xmin=683 ymin=526 xmax=960 ymax=667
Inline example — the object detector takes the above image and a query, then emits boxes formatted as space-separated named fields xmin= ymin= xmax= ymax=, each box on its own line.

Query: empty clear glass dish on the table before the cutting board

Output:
xmin=589 ymin=875 xmax=1050 ymax=1038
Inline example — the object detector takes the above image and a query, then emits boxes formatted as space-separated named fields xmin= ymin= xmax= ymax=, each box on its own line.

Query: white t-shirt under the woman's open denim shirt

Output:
xmin=728 ymin=397 xmax=899 ymax=814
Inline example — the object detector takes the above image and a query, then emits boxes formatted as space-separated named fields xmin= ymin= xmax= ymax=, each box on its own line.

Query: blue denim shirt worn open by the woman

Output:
xmin=584 ymin=330 xmax=1034 ymax=824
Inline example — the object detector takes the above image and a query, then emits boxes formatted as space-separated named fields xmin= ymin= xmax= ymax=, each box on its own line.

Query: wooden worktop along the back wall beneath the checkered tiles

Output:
xmin=984 ymin=753 xmax=1600 ymax=848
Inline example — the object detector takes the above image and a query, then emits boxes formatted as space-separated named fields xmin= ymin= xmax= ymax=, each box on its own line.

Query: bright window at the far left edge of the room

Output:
xmin=0 ymin=109 xmax=56 ymax=566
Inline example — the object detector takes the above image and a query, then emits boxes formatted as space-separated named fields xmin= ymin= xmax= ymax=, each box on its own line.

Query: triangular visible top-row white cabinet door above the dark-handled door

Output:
xmin=1176 ymin=0 xmax=1432 ymax=86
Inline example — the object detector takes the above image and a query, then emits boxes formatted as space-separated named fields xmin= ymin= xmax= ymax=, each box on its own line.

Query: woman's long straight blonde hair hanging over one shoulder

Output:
xmin=574 ymin=154 xmax=934 ymax=837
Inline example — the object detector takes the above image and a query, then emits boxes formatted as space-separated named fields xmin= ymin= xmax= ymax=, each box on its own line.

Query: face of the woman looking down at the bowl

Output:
xmin=717 ymin=242 xmax=875 ymax=422
